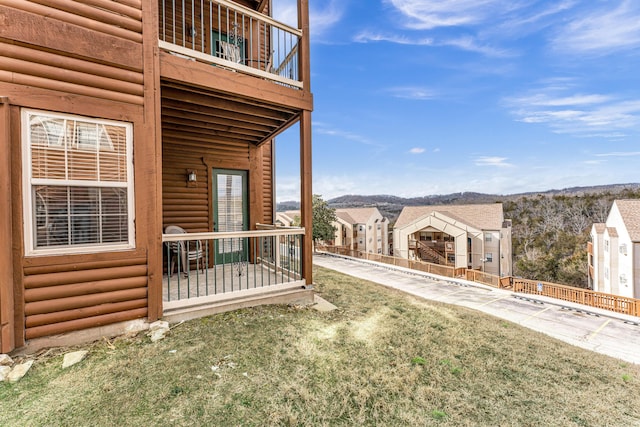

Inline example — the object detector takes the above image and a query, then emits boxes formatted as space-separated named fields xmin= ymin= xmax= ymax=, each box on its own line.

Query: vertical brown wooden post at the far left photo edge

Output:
xmin=0 ymin=97 xmax=15 ymax=353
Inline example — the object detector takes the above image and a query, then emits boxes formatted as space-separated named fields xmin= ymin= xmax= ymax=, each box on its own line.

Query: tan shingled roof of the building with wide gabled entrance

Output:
xmin=394 ymin=203 xmax=504 ymax=230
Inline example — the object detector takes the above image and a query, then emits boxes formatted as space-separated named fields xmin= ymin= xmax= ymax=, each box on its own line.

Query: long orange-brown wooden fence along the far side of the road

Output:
xmin=318 ymin=246 xmax=640 ymax=316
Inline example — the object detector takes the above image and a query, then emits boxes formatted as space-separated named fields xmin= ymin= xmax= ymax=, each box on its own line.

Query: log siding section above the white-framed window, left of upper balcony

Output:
xmin=0 ymin=0 xmax=143 ymax=105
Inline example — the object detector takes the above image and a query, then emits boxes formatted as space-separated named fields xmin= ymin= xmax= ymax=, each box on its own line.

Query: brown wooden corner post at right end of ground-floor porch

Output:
xmin=300 ymin=111 xmax=313 ymax=285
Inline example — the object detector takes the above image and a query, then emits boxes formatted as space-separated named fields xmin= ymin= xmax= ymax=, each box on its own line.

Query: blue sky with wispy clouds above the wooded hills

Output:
xmin=273 ymin=0 xmax=640 ymax=201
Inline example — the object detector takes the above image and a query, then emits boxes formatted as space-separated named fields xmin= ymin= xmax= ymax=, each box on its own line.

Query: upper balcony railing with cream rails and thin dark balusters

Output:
xmin=158 ymin=0 xmax=304 ymax=89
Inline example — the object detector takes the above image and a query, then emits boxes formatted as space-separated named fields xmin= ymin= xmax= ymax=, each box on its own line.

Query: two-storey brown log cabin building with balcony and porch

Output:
xmin=0 ymin=0 xmax=313 ymax=353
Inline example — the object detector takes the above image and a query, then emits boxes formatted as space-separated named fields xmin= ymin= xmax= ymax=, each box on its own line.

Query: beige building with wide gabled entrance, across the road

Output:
xmin=393 ymin=203 xmax=513 ymax=276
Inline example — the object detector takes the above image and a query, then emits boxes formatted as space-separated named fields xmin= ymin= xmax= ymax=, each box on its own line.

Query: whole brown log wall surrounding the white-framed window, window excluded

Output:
xmin=0 ymin=0 xmax=152 ymax=351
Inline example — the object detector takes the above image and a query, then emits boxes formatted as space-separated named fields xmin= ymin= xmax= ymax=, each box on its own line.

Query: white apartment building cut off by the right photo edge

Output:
xmin=588 ymin=200 xmax=640 ymax=298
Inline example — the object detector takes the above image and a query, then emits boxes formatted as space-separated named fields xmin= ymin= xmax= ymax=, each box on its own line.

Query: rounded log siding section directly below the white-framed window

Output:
xmin=23 ymin=251 xmax=148 ymax=339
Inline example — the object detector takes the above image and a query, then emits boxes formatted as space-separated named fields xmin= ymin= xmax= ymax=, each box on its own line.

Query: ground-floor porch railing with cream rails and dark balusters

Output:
xmin=162 ymin=227 xmax=305 ymax=307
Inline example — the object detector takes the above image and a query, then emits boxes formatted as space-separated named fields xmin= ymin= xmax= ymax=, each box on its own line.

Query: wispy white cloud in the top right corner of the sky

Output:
xmin=553 ymin=0 xmax=640 ymax=55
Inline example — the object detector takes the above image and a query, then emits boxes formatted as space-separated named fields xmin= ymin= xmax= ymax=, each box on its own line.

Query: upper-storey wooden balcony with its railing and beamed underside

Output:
xmin=158 ymin=0 xmax=313 ymax=145
